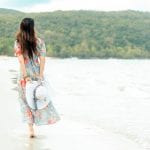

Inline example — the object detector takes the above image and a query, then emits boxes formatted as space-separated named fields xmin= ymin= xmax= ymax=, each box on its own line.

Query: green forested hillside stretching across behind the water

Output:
xmin=0 ymin=9 xmax=150 ymax=58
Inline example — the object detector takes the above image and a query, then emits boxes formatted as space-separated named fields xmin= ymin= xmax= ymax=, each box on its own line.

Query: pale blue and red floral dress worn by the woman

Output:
xmin=14 ymin=38 xmax=60 ymax=125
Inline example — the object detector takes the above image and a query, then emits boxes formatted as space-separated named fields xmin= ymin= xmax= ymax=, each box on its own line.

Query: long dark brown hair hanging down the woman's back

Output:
xmin=16 ymin=18 xmax=37 ymax=59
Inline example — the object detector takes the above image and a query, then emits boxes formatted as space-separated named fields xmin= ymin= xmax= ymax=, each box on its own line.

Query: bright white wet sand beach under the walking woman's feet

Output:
xmin=0 ymin=56 xmax=144 ymax=150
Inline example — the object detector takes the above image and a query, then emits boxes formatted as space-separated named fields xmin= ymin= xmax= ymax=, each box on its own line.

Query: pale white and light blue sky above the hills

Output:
xmin=0 ymin=0 xmax=150 ymax=12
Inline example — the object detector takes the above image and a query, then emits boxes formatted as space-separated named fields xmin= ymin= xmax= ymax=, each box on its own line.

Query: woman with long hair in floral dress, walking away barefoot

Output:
xmin=14 ymin=18 xmax=60 ymax=138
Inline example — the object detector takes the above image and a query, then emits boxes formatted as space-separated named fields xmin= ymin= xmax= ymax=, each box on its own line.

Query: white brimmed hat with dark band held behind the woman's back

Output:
xmin=25 ymin=81 xmax=50 ymax=110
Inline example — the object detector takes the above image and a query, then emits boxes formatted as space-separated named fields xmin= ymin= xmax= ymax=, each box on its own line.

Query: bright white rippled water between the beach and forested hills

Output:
xmin=0 ymin=57 xmax=150 ymax=149
